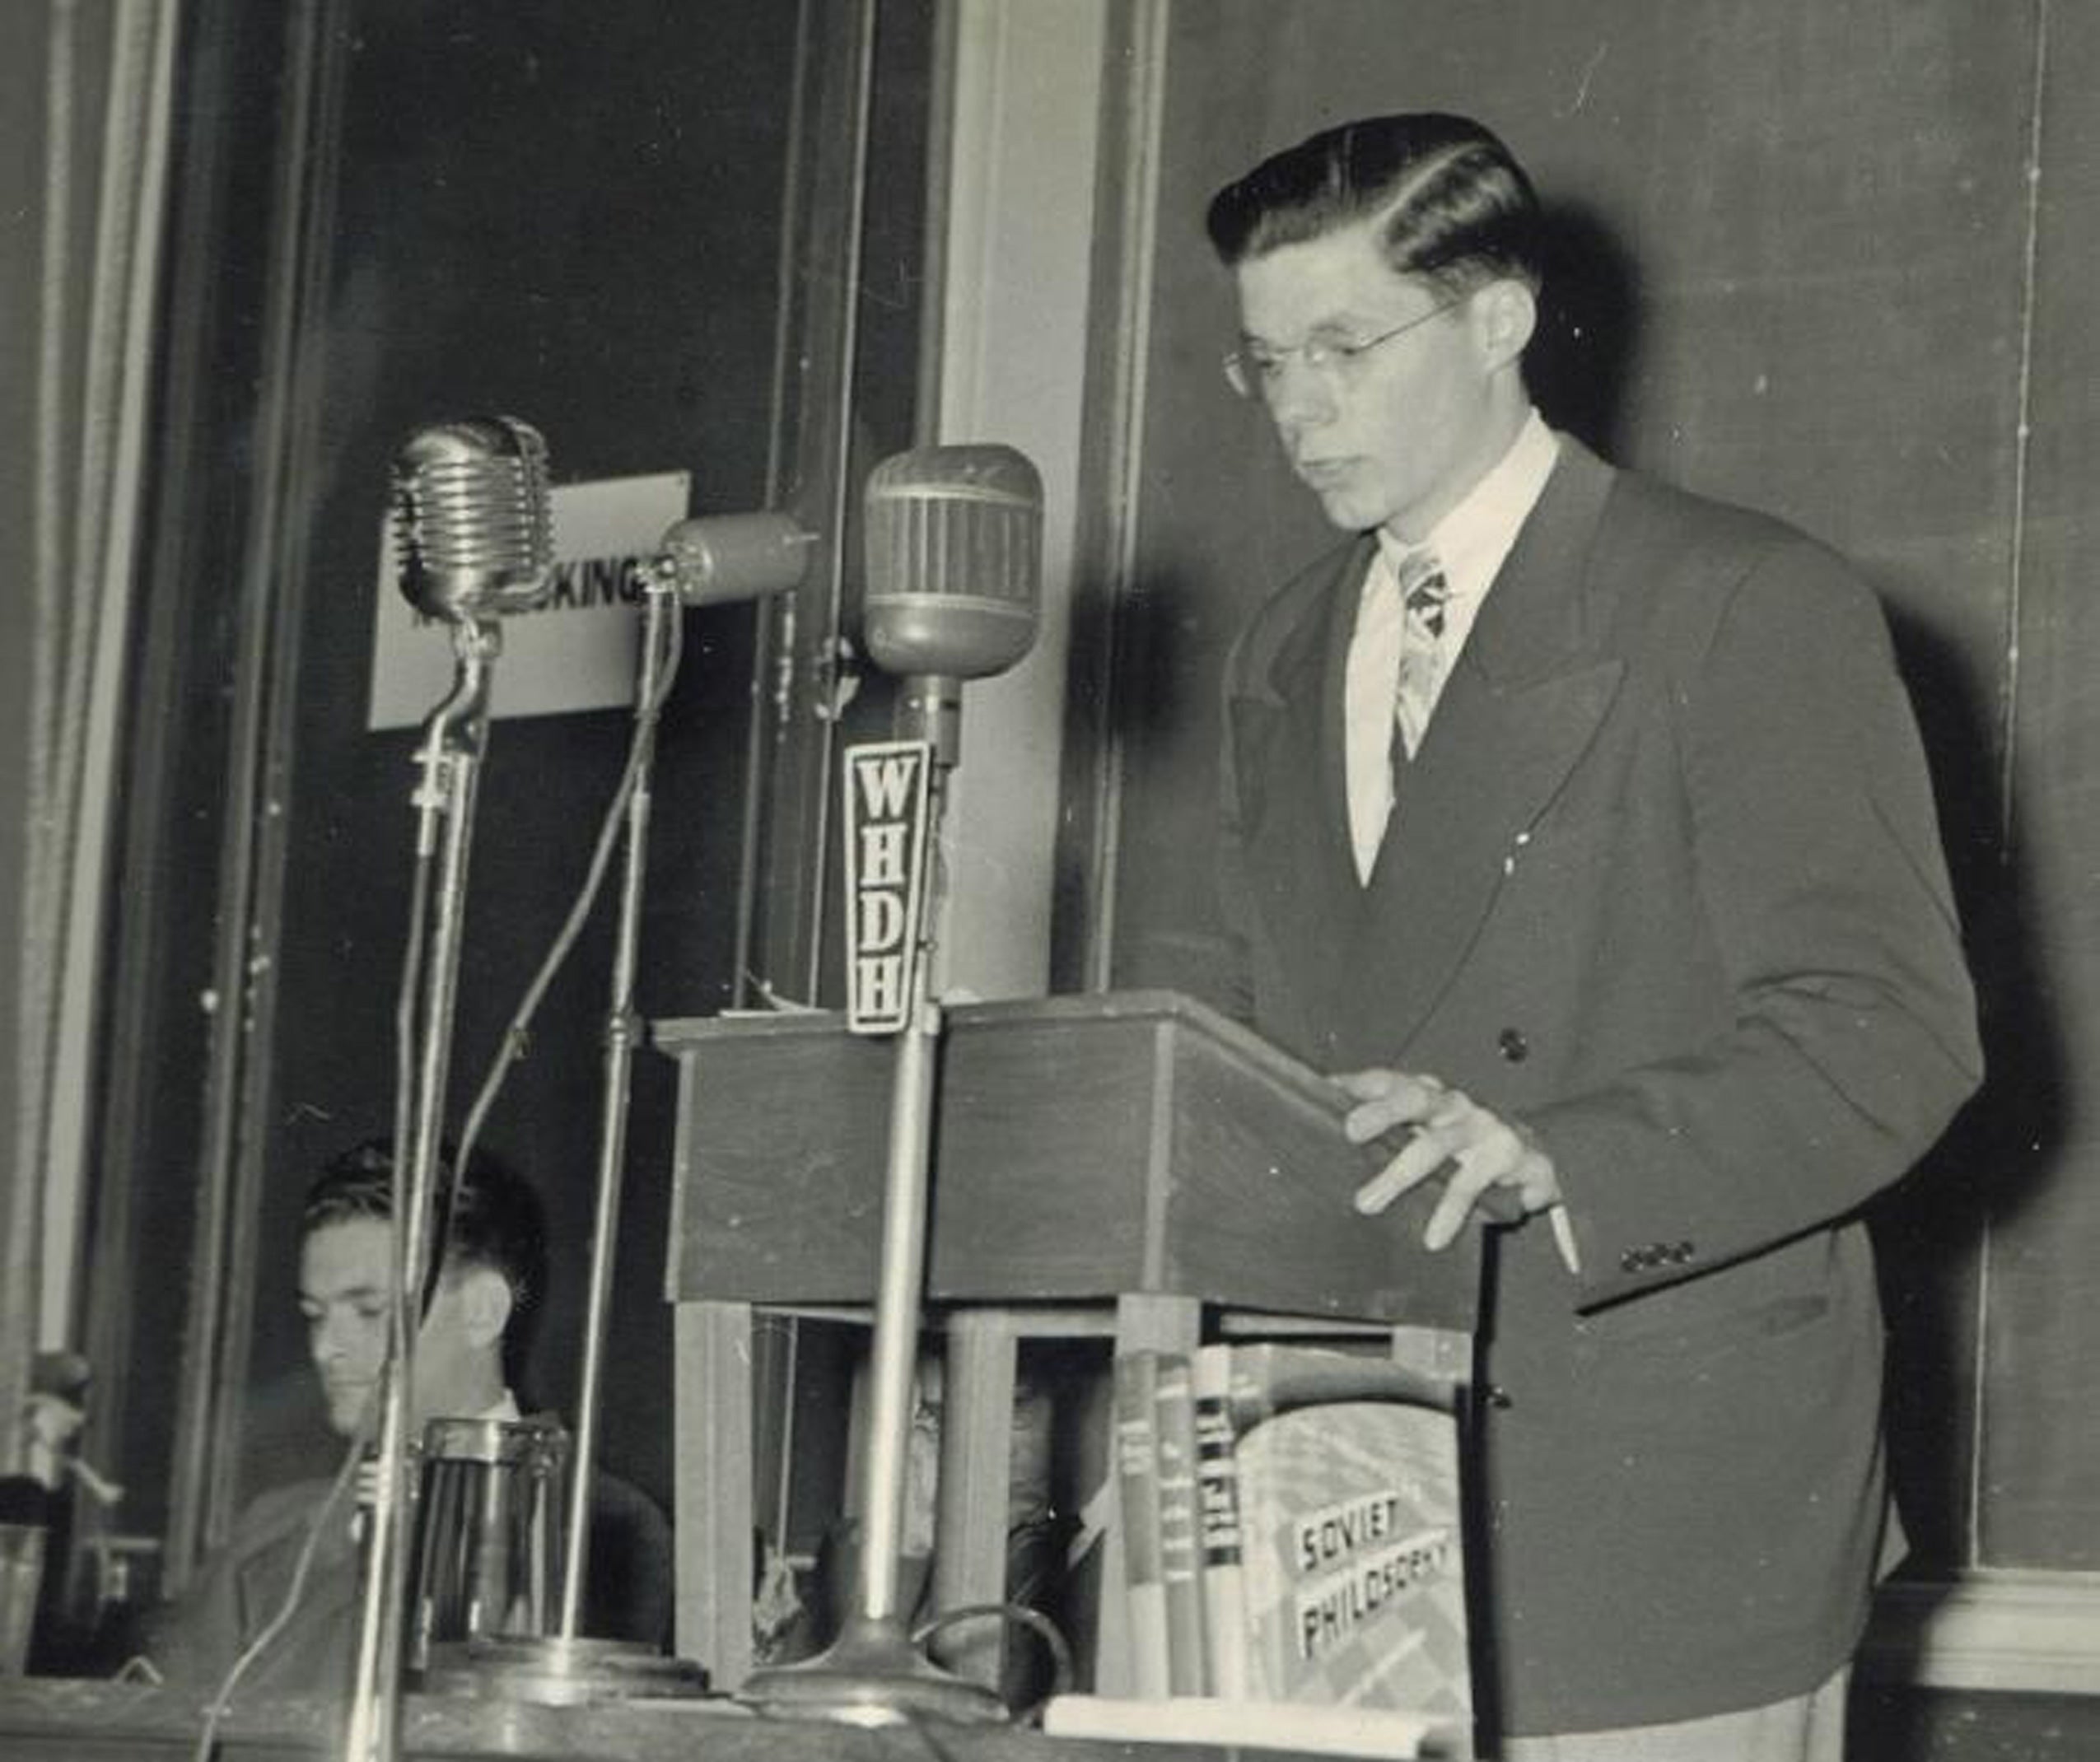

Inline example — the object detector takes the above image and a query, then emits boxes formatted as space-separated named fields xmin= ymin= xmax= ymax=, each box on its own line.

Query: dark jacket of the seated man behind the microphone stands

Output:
xmin=145 ymin=1444 xmax=672 ymax=1701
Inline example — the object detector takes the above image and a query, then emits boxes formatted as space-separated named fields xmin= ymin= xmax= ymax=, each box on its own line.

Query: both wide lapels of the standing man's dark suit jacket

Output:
xmin=1226 ymin=439 xmax=1623 ymax=1060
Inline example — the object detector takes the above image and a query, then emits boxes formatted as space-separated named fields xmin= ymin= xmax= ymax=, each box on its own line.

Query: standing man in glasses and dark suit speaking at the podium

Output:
xmin=1210 ymin=115 xmax=1981 ymax=1762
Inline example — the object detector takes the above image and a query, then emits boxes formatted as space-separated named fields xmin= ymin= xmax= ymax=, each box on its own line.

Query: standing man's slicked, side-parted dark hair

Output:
xmin=1207 ymin=114 xmax=1542 ymax=294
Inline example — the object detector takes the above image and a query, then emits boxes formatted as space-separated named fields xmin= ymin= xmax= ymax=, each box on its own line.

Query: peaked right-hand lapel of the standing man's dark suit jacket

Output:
xmin=1342 ymin=441 xmax=1623 ymax=1056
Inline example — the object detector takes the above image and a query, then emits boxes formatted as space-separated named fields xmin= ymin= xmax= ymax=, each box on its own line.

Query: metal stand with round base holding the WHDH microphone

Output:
xmin=741 ymin=674 xmax=1006 ymax=1727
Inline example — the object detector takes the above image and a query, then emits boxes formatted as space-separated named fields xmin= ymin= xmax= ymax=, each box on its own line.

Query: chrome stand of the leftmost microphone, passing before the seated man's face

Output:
xmin=344 ymin=618 xmax=502 ymax=1762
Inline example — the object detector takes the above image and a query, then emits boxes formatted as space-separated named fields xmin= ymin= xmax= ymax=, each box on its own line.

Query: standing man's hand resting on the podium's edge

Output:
xmin=1336 ymin=1071 xmax=1561 ymax=1247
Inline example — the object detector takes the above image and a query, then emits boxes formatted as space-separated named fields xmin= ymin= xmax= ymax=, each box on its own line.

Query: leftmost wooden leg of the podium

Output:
xmin=672 ymin=1302 xmax=754 ymax=1690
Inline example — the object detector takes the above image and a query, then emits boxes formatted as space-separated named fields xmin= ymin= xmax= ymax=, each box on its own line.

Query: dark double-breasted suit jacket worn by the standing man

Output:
xmin=1222 ymin=441 xmax=1981 ymax=1732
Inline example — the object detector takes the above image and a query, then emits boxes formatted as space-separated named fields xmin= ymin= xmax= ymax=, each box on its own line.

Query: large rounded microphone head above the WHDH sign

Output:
xmin=861 ymin=441 xmax=1043 ymax=678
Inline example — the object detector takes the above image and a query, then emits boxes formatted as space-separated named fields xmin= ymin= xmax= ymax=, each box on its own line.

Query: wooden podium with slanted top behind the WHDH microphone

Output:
xmin=653 ymin=991 xmax=1481 ymax=1689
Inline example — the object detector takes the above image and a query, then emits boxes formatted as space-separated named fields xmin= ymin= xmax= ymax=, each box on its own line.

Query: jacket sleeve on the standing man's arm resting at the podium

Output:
xmin=1527 ymin=538 xmax=1982 ymax=1307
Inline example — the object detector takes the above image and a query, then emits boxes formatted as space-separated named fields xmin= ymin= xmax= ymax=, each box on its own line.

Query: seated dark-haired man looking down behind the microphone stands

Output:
xmin=147 ymin=1138 xmax=672 ymax=1694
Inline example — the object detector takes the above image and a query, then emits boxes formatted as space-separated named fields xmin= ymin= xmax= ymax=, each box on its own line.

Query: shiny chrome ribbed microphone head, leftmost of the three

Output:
xmin=393 ymin=416 xmax=554 ymax=619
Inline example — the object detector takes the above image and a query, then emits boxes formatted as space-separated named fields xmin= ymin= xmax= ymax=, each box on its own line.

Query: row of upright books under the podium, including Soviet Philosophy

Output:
xmin=1066 ymin=1344 xmax=1472 ymax=1741
